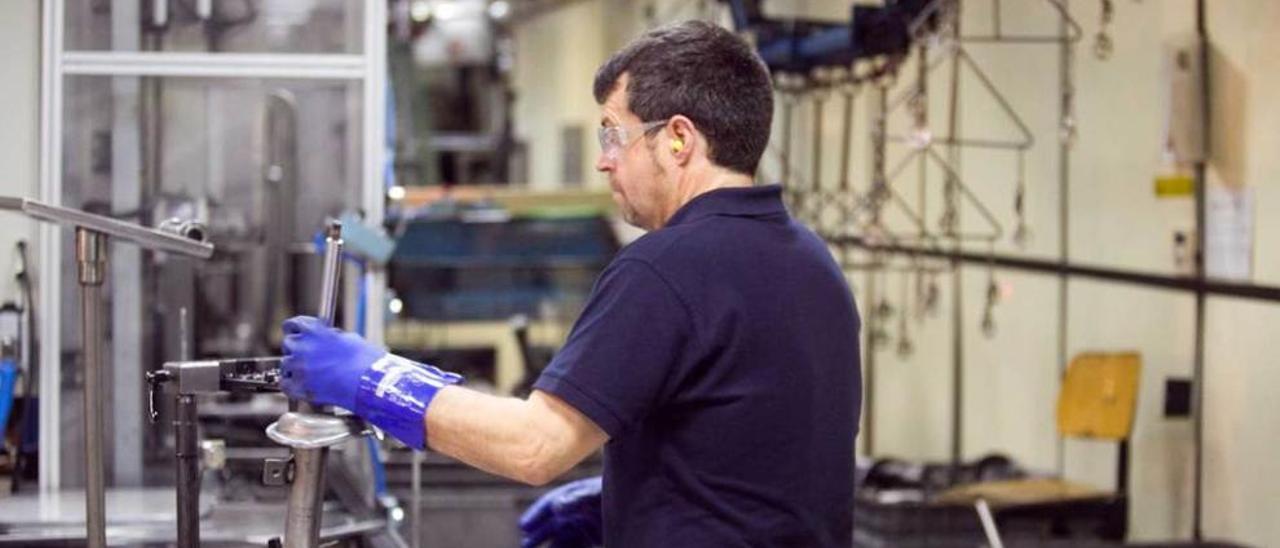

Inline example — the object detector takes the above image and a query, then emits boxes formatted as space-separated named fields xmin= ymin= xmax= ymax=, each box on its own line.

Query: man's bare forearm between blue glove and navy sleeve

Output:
xmin=425 ymin=387 xmax=608 ymax=485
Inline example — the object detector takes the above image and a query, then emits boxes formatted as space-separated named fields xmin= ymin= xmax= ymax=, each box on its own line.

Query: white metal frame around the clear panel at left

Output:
xmin=38 ymin=0 xmax=387 ymax=509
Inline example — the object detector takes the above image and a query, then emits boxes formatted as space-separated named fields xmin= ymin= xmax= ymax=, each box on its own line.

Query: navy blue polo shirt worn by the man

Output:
xmin=534 ymin=186 xmax=861 ymax=548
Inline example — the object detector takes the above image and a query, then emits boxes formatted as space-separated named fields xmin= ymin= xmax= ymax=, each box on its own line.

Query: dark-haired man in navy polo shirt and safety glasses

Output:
xmin=283 ymin=22 xmax=861 ymax=548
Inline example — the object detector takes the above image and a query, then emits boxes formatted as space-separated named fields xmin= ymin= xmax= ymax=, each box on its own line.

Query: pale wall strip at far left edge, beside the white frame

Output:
xmin=0 ymin=1 xmax=40 ymax=302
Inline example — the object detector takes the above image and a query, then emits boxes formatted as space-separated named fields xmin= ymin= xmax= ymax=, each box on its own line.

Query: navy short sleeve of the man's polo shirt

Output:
xmin=534 ymin=259 xmax=695 ymax=438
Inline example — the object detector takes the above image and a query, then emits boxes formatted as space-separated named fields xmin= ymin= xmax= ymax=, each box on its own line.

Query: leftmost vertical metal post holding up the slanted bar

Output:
xmin=76 ymin=228 xmax=106 ymax=548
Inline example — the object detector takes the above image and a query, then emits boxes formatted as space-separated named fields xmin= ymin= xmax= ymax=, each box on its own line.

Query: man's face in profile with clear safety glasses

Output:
xmin=595 ymin=74 xmax=672 ymax=230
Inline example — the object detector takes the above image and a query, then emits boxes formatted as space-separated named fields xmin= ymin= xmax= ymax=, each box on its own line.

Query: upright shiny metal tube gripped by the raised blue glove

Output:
xmin=284 ymin=220 xmax=342 ymax=548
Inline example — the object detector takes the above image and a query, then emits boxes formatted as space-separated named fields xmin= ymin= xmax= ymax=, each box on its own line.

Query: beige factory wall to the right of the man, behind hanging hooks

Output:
xmin=763 ymin=0 xmax=1280 ymax=545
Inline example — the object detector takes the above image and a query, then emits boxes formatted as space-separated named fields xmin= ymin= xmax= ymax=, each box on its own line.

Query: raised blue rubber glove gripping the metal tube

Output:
xmin=280 ymin=316 xmax=462 ymax=449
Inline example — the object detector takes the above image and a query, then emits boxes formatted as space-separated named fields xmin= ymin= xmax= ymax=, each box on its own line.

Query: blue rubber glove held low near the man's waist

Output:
xmin=520 ymin=476 xmax=604 ymax=548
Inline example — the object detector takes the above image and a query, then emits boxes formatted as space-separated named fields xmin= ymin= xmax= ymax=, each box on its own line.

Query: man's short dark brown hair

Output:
xmin=594 ymin=20 xmax=773 ymax=175
